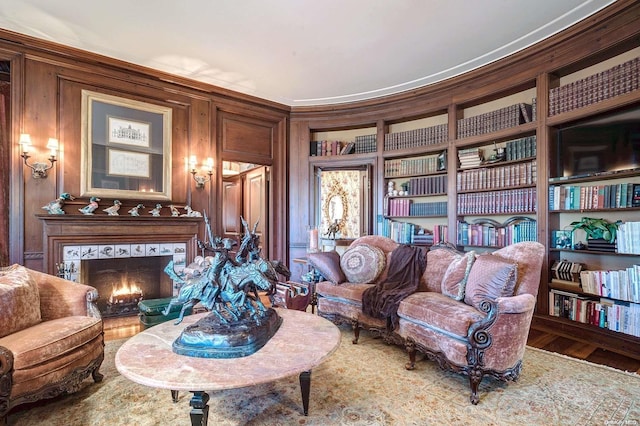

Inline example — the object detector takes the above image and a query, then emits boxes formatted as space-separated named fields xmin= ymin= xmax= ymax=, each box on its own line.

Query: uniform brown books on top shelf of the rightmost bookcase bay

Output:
xmin=549 ymin=58 xmax=640 ymax=116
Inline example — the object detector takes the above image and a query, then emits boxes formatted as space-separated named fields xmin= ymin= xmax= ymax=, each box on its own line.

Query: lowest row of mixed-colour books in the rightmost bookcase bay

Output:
xmin=549 ymin=289 xmax=640 ymax=337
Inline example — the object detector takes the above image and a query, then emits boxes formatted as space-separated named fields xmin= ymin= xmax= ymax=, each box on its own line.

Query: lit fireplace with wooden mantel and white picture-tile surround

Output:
xmin=38 ymin=215 xmax=203 ymax=316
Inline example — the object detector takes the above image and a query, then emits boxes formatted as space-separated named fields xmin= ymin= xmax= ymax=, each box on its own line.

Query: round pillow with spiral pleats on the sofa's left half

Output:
xmin=340 ymin=244 xmax=386 ymax=283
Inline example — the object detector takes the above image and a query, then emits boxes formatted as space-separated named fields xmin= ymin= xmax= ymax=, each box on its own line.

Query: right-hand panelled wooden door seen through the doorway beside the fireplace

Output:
xmin=242 ymin=166 xmax=269 ymax=259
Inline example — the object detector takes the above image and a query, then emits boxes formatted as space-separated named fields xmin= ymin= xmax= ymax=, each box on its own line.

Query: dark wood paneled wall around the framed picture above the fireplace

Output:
xmin=0 ymin=30 xmax=289 ymax=270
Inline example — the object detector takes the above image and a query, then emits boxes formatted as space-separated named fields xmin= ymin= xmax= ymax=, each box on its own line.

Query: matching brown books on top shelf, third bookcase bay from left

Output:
xmin=457 ymin=103 xmax=533 ymax=138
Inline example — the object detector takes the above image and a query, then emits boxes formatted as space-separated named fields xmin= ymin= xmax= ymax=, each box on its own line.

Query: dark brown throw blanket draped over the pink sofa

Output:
xmin=362 ymin=244 xmax=427 ymax=328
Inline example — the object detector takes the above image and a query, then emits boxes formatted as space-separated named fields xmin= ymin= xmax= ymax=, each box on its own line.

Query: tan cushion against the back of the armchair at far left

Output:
xmin=0 ymin=264 xmax=42 ymax=337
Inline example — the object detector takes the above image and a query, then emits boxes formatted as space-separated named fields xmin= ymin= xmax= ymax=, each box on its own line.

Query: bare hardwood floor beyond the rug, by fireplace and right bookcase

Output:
xmin=104 ymin=316 xmax=640 ymax=374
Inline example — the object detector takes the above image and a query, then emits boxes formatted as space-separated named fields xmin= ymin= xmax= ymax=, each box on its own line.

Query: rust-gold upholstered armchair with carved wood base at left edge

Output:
xmin=0 ymin=265 xmax=104 ymax=424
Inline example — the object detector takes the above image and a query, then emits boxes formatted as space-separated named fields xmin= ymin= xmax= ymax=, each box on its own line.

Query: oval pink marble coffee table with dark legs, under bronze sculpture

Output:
xmin=115 ymin=309 xmax=340 ymax=425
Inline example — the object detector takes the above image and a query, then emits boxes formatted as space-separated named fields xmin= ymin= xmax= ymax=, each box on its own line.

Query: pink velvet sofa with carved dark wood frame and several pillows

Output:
xmin=308 ymin=236 xmax=544 ymax=404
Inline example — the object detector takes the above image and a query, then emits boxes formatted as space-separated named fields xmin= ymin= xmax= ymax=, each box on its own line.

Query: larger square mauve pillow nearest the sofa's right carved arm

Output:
xmin=464 ymin=254 xmax=518 ymax=309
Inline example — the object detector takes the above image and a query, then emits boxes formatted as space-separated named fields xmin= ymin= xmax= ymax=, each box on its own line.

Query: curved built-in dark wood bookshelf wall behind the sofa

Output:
xmin=292 ymin=0 xmax=640 ymax=357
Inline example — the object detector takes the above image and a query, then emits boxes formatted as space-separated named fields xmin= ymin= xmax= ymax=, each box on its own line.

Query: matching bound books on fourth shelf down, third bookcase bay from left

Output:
xmin=457 ymin=188 xmax=537 ymax=215
